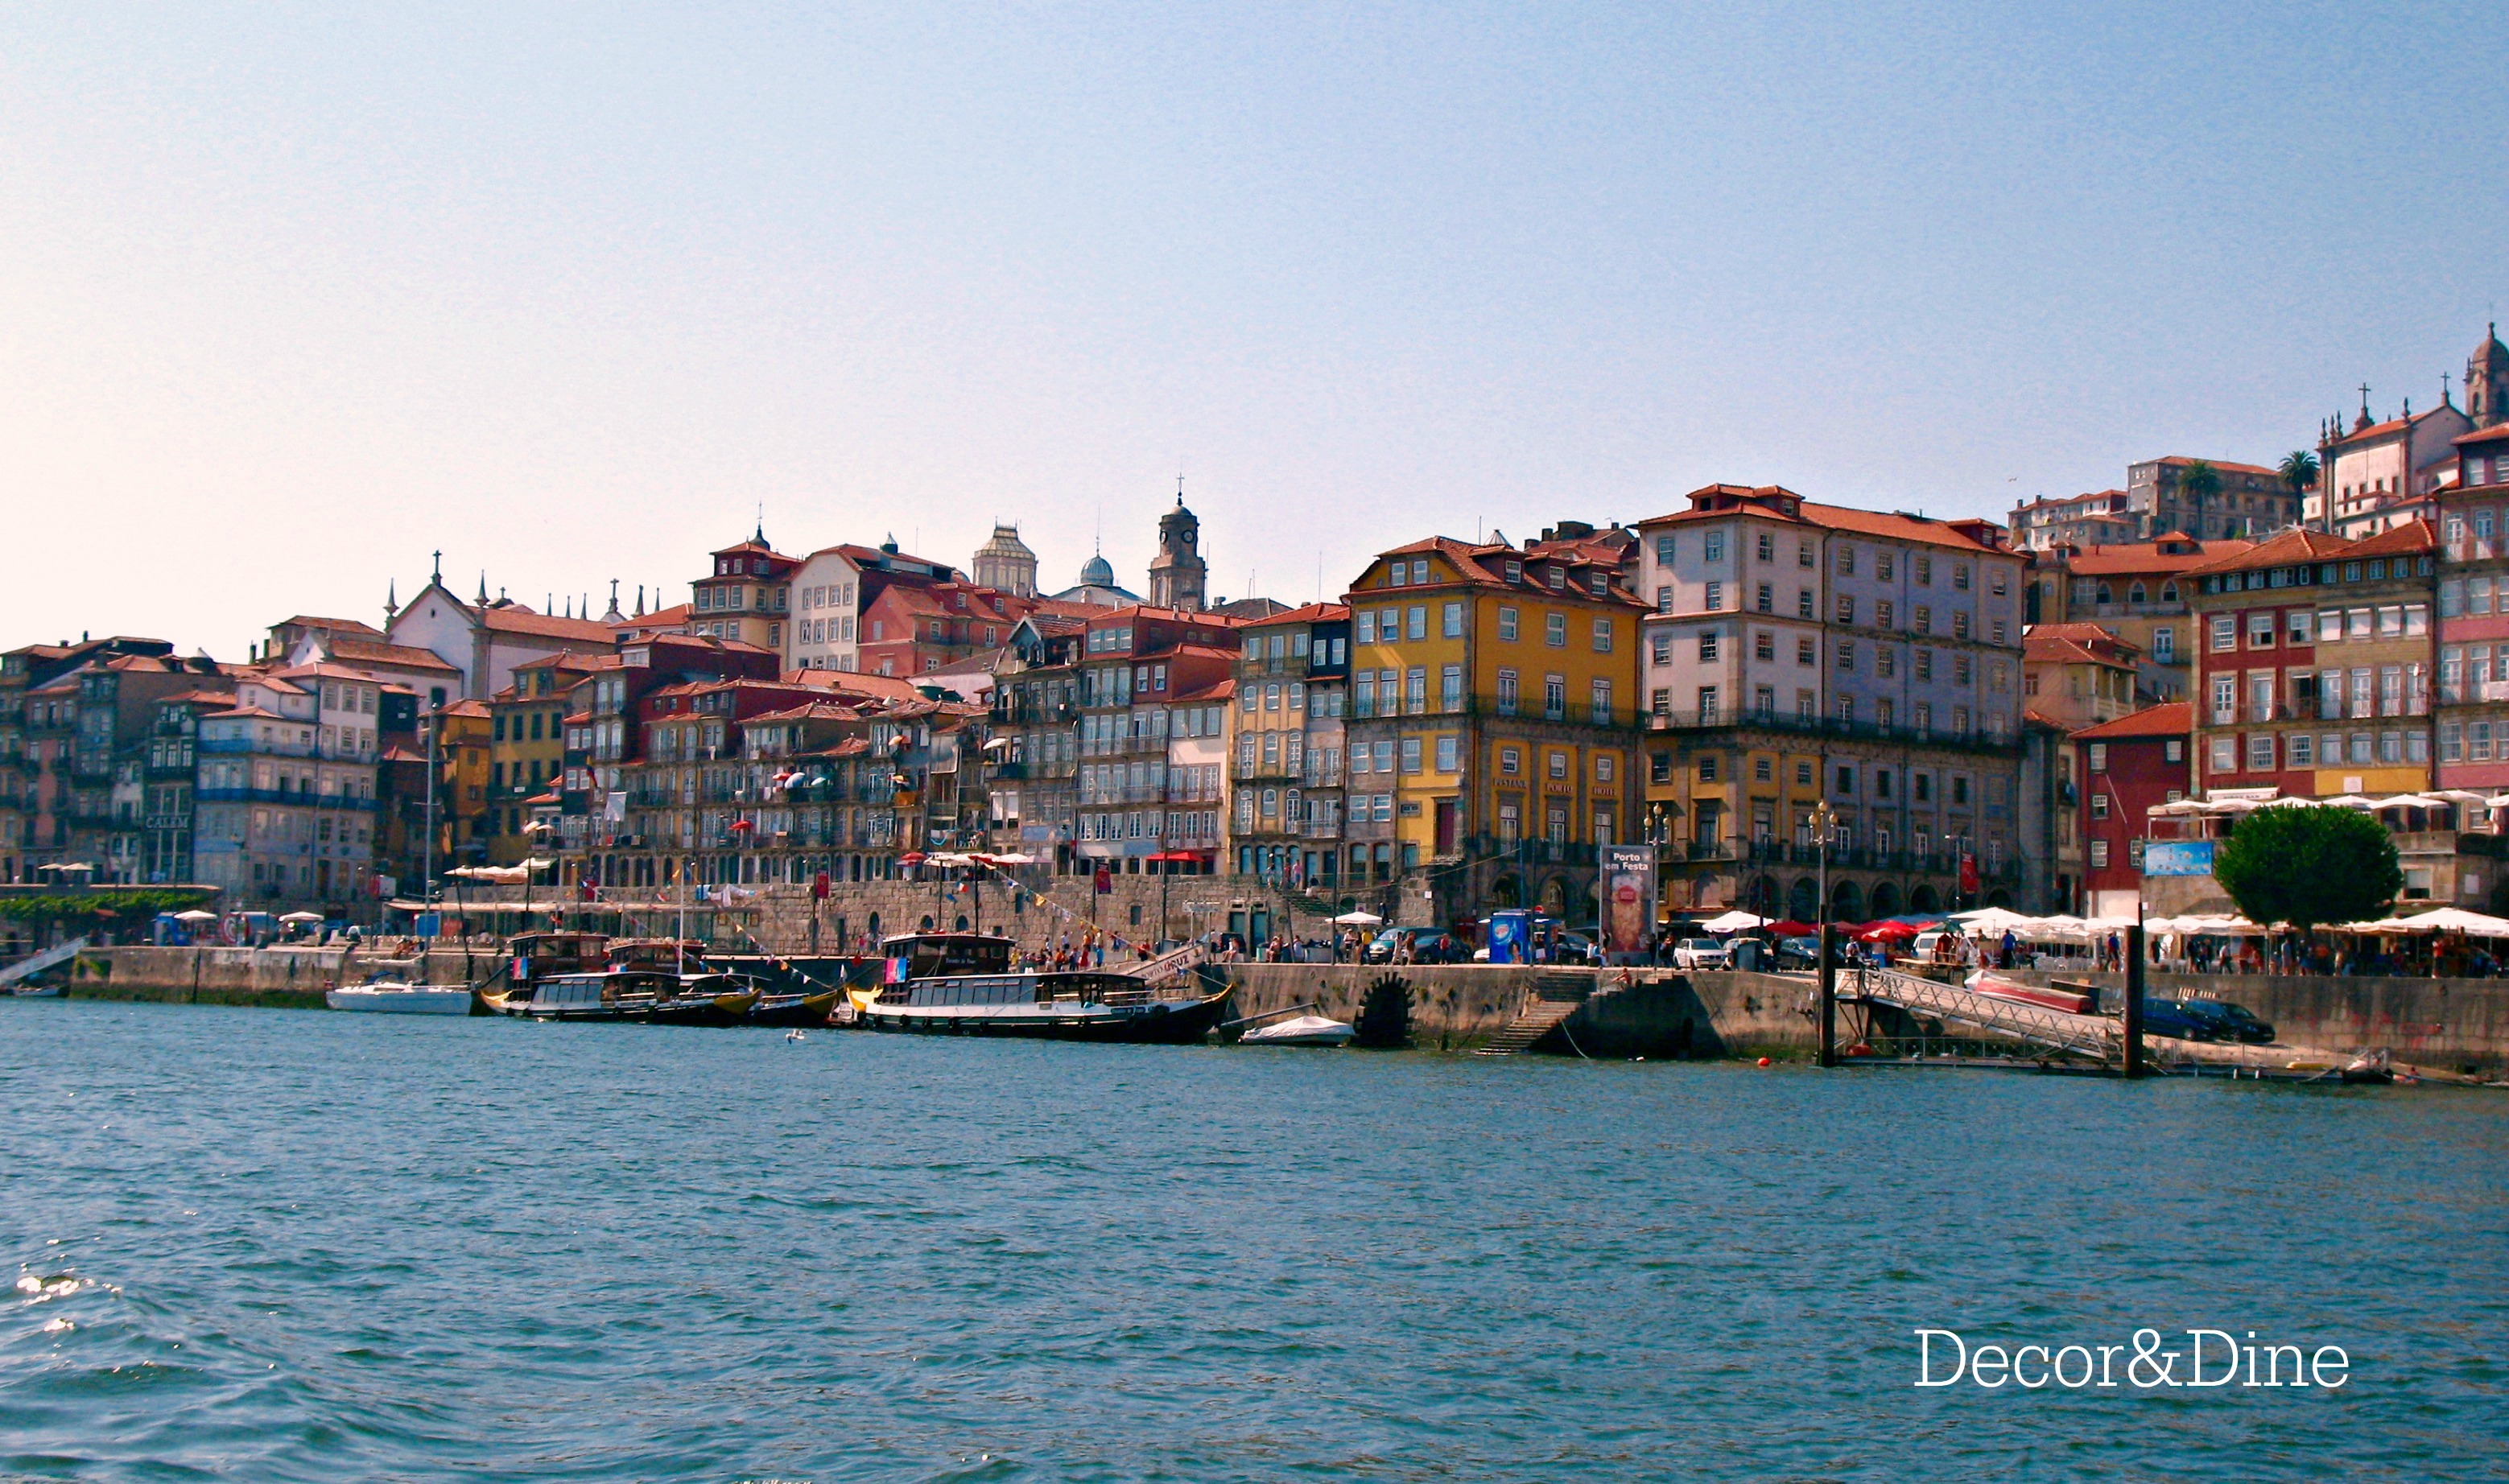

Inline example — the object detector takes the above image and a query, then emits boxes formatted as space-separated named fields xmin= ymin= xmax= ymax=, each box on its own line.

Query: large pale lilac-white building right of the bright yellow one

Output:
xmin=1633 ymin=484 xmax=2024 ymax=920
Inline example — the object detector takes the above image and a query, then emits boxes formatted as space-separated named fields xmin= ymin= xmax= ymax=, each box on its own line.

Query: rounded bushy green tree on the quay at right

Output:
xmin=2213 ymin=805 xmax=2404 ymax=933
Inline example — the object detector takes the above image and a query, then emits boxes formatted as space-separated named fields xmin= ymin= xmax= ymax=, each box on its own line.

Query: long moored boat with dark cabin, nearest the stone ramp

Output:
xmin=848 ymin=933 xmax=1227 ymax=1043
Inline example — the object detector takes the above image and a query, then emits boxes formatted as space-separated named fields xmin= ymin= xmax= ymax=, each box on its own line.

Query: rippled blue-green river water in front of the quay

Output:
xmin=0 ymin=1000 xmax=2509 ymax=1482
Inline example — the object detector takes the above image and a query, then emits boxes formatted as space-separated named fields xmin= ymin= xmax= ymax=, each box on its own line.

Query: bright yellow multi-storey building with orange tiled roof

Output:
xmin=1343 ymin=524 xmax=1644 ymax=922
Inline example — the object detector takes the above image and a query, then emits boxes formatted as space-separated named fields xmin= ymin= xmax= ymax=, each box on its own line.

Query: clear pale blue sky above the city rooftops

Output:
xmin=0 ymin=5 xmax=2509 ymax=657
